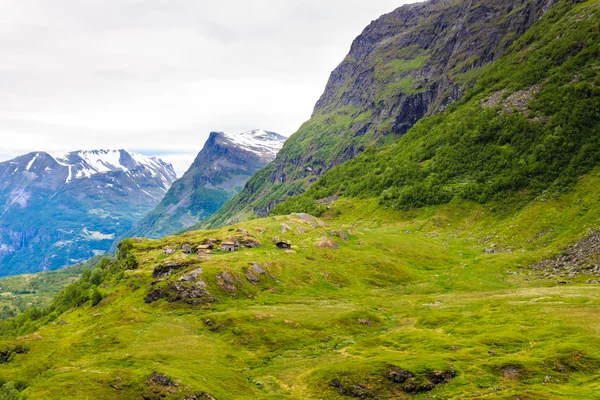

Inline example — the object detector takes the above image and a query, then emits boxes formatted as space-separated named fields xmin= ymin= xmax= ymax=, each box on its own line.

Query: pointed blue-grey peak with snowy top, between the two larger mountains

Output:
xmin=127 ymin=129 xmax=286 ymax=238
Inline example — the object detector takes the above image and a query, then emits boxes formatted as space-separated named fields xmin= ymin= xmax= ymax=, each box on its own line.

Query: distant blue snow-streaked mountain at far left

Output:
xmin=0 ymin=150 xmax=176 ymax=275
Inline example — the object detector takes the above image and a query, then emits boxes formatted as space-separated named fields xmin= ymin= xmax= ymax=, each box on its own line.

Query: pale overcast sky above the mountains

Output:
xmin=0 ymin=0 xmax=412 ymax=176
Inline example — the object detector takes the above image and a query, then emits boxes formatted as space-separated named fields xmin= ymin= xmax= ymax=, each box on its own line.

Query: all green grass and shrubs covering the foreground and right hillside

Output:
xmin=0 ymin=1 xmax=600 ymax=400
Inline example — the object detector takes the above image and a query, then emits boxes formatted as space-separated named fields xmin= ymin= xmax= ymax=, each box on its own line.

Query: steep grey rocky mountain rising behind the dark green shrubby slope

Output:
xmin=203 ymin=0 xmax=555 ymax=227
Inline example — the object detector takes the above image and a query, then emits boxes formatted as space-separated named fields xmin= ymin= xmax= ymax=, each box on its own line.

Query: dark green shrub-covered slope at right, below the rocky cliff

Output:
xmin=274 ymin=2 xmax=600 ymax=214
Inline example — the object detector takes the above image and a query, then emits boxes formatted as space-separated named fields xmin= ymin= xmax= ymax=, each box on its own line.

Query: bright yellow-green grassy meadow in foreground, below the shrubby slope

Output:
xmin=0 ymin=171 xmax=600 ymax=399
